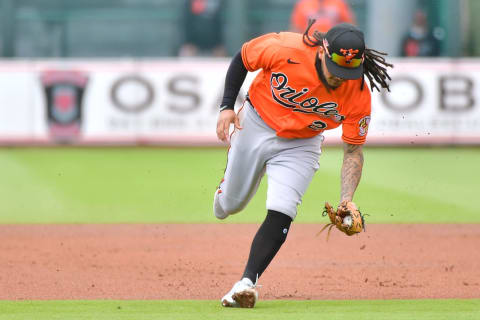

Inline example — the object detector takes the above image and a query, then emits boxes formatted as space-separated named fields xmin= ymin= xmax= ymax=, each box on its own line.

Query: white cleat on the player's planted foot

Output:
xmin=221 ymin=278 xmax=258 ymax=308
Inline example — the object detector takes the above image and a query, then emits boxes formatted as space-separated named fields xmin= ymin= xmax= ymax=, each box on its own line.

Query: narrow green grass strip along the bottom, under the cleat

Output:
xmin=0 ymin=299 xmax=480 ymax=320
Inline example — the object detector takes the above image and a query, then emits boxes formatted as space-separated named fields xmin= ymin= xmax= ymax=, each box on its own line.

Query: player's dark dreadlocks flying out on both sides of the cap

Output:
xmin=303 ymin=19 xmax=393 ymax=92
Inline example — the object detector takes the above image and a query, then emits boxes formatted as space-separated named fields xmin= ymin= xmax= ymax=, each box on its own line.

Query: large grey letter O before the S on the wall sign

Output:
xmin=110 ymin=75 xmax=155 ymax=113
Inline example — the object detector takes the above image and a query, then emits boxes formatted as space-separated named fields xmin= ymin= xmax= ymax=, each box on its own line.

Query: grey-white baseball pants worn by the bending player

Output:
xmin=218 ymin=101 xmax=323 ymax=220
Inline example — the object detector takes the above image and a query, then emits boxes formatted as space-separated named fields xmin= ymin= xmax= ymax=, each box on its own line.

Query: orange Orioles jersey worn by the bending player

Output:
xmin=242 ymin=32 xmax=371 ymax=144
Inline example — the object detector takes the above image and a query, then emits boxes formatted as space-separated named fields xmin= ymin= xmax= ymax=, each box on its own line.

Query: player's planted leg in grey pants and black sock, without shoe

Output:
xmin=238 ymin=137 xmax=322 ymax=283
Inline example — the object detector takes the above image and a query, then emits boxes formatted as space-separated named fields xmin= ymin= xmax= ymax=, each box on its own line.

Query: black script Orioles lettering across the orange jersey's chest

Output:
xmin=270 ymin=72 xmax=345 ymax=121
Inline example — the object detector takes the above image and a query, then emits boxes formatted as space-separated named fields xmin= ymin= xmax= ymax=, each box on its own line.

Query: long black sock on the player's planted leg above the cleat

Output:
xmin=242 ymin=210 xmax=292 ymax=283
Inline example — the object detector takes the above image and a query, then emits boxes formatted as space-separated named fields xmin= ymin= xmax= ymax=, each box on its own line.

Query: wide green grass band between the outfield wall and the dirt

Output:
xmin=0 ymin=147 xmax=480 ymax=223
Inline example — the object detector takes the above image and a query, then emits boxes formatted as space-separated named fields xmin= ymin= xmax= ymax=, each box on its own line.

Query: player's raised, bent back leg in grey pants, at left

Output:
xmin=213 ymin=102 xmax=274 ymax=219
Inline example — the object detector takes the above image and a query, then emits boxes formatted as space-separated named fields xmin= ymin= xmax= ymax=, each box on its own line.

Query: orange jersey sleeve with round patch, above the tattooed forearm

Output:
xmin=342 ymin=90 xmax=372 ymax=144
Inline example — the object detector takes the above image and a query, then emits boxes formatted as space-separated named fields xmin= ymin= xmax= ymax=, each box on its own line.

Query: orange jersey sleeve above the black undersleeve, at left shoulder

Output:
xmin=242 ymin=33 xmax=280 ymax=71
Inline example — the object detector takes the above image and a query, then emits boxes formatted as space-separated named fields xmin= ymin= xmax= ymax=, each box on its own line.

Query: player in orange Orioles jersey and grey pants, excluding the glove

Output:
xmin=213 ymin=21 xmax=392 ymax=308
